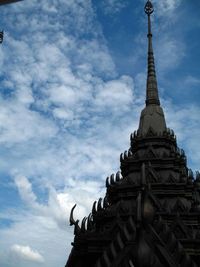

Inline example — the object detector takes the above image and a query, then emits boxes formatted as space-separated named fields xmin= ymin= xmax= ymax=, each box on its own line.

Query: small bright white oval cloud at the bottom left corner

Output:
xmin=11 ymin=244 xmax=44 ymax=263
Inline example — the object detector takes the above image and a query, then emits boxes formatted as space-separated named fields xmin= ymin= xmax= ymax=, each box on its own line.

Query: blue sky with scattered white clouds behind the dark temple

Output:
xmin=0 ymin=0 xmax=200 ymax=267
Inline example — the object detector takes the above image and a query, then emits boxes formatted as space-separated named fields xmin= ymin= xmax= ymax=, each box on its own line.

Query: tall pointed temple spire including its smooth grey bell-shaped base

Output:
xmin=138 ymin=0 xmax=166 ymax=135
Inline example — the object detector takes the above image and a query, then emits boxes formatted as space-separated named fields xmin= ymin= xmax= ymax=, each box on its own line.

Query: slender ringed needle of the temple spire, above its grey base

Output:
xmin=144 ymin=0 xmax=160 ymax=106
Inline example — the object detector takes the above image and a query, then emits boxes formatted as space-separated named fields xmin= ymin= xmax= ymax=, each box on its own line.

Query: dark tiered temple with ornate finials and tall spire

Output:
xmin=66 ymin=1 xmax=200 ymax=267
